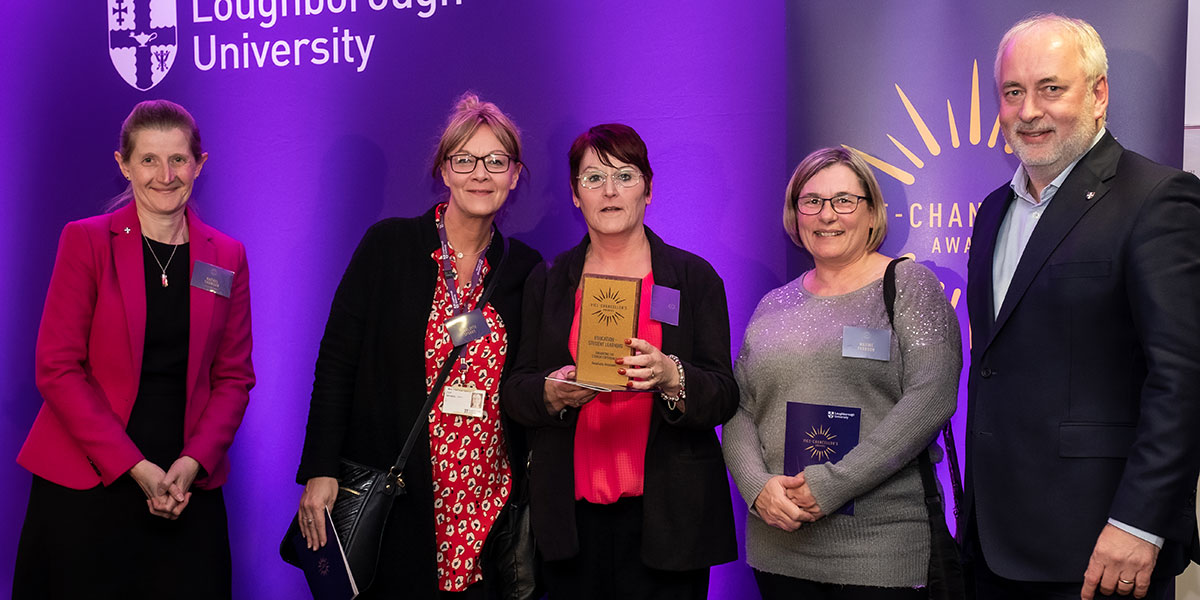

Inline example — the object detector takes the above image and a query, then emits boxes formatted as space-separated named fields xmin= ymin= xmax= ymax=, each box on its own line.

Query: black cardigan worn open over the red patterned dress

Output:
xmin=296 ymin=209 xmax=541 ymax=598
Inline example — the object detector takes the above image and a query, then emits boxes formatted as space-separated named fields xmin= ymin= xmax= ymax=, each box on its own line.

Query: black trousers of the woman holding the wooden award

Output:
xmin=542 ymin=498 xmax=708 ymax=600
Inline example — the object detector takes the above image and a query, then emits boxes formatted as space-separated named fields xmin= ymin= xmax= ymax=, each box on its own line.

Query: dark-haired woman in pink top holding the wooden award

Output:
xmin=503 ymin=125 xmax=737 ymax=599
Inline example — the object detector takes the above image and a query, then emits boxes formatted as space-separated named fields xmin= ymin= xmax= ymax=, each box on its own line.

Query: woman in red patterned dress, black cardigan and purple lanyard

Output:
xmin=296 ymin=94 xmax=541 ymax=599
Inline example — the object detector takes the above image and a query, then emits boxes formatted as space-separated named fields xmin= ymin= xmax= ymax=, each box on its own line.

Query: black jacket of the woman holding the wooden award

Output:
xmin=500 ymin=228 xmax=738 ymax=570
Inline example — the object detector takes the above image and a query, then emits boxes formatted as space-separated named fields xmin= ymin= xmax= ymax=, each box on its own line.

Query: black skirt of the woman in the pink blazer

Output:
xmin=12 ymin=475 xmax=233 ymax=600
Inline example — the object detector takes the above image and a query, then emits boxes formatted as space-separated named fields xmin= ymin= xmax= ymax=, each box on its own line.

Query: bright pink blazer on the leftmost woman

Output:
xmin=17 ymin=203 xmax=254 ymax=490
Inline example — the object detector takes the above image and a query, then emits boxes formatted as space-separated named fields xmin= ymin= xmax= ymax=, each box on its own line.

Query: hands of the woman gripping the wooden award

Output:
xmin=542 ymin=337 xmax=684 ymax=414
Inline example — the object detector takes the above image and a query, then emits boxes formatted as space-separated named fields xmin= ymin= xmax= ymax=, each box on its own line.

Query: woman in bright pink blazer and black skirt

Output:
xmin=13 ymin=101 xmax=254 ymax=599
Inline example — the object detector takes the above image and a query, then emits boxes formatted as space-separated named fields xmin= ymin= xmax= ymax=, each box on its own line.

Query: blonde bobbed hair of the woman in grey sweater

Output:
xmin=784 ymin=148 xmax=888 ymax=252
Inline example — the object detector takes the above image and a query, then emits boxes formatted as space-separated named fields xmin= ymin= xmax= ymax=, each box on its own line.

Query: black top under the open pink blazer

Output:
xmin=125 ymin=239 xmax=191 ymax=469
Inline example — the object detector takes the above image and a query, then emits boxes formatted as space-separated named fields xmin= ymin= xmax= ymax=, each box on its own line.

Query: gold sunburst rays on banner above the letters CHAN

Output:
xmin=842 ymin=60 xmax=1013 ymax=185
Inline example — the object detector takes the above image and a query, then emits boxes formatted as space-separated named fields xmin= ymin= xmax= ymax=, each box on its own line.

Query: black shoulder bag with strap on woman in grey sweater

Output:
xmin=883 ymin=257 xmax=968 ymax=600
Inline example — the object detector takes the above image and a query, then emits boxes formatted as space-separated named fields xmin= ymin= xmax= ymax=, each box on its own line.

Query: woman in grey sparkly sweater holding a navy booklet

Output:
xmin=724 ymin=148 xmax=962 ymax=600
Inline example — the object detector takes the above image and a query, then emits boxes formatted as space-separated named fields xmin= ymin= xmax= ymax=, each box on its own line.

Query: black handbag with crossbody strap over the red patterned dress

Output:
xmin=280 ymin=238 xmax=509 ymax=590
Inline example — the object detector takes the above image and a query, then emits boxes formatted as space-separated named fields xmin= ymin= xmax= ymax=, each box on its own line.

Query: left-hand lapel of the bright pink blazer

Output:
xmin=110 ymin=200 xmax=146 ymax=372
